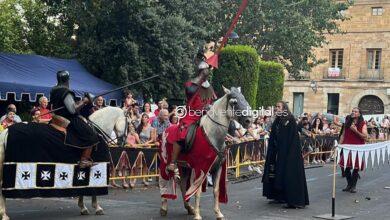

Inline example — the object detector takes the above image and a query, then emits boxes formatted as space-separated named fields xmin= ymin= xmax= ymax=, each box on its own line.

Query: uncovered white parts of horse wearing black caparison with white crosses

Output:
xmin=0 ymin=107 xmax=126 ymax=220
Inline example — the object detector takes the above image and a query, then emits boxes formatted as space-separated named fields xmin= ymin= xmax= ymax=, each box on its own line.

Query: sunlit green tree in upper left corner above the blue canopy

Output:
xmin=0 ymin=0 xmax=72 ymax=57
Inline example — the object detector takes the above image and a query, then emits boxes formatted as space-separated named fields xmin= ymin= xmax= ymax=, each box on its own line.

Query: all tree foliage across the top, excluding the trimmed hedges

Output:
xmin=0 ymin=0 xmax=348 ymax=98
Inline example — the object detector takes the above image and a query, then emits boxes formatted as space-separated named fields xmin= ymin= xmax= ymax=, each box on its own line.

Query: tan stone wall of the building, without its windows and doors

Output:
xmin=283 ymin=0 xmax=390 ymax=115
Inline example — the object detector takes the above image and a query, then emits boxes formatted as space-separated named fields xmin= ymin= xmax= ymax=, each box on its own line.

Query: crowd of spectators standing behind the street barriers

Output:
xmin=0 ymin=91 xmax=390 ymax=187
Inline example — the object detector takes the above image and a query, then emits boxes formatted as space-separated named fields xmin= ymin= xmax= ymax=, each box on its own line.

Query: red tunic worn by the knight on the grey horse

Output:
xmin=172 ymin=81 xmax=216 ymax=142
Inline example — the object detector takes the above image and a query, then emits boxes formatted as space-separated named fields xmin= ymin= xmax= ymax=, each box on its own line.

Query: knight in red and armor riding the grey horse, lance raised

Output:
xmin=167 ymin=53 xmax=216 ymax=173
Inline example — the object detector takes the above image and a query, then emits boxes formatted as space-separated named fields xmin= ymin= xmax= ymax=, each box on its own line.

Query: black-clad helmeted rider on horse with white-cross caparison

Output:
xmin=50 ymin=70 xmax=99 ymax=168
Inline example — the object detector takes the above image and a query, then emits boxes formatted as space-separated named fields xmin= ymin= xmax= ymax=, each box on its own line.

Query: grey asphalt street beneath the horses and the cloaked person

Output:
xmin=7 ymin=165 xmax=390 ymax=220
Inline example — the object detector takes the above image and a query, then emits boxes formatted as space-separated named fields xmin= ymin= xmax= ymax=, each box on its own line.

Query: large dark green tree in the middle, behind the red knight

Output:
xmin=66 ymin=0 xmax=225 ymax=98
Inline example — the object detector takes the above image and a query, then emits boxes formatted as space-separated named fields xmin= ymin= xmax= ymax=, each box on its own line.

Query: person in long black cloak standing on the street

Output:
xmin=262 ymin=101 xmax=309 ymax=208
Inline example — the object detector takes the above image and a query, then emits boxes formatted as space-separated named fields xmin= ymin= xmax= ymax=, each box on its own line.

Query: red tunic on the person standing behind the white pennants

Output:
xmin=339 ymin=121 xmax=366 ymax=171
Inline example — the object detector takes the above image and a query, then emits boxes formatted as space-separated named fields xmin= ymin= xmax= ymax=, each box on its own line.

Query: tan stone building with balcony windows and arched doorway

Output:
xmin=283 ymin=0 xmax=390 ymax=115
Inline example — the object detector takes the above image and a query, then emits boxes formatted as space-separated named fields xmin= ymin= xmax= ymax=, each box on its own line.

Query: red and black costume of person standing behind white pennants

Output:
xmin=339 ymin=110 xmax=366 ymax=193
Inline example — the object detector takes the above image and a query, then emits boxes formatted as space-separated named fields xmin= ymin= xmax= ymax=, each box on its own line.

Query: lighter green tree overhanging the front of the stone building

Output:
xmin=220 ymin=0 xmax=350 ymax=77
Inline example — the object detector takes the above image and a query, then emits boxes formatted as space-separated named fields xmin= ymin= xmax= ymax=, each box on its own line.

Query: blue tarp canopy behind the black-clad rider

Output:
xmin=0 ymin=53 xmax=121 ymax=105
